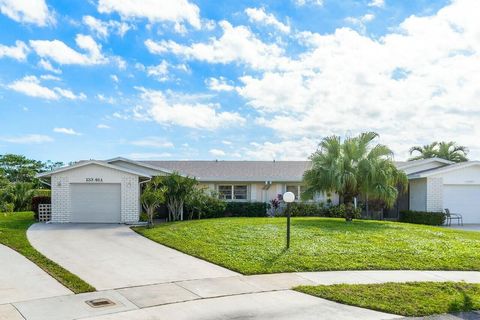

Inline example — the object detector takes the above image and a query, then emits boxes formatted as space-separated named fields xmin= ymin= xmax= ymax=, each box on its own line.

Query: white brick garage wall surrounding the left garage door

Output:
xmin=51 ymin=164 xmax=140 ymax=223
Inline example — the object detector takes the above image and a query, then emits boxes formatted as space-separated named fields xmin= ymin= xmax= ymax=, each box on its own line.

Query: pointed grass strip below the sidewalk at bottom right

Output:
xmin=295 ymin=282 xmax=480 ymax=317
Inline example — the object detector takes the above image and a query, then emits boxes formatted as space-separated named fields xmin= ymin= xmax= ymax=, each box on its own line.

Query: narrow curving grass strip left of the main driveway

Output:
xmin=0 ymin=212 xmax=95 ymax=293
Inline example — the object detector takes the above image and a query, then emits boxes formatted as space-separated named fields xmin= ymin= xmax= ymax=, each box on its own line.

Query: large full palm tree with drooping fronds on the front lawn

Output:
xmin=303 ymin=132 xmax=408 ymax=220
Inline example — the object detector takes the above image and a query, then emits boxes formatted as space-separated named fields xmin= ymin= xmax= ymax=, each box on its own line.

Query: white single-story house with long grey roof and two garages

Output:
xmin=38 ymin=157 xmax=480 ymax=223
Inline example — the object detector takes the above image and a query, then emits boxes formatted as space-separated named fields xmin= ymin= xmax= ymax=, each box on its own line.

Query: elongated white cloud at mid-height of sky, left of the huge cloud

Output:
xmin=132 ymin=88 xmax=245 ymax=130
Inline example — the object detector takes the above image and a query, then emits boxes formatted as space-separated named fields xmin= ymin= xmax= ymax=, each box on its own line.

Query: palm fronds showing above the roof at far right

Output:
xmin=408 ymin=141 xmax=468 ymax=162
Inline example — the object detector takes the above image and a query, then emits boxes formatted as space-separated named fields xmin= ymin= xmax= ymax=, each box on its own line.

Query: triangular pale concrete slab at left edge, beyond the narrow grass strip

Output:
xmin=0 ymin=244 xmax=72 ymax=304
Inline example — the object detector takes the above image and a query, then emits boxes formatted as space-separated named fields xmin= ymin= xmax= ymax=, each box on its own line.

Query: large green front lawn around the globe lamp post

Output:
xmin=135 ymin=218 xmax=480 ymax=274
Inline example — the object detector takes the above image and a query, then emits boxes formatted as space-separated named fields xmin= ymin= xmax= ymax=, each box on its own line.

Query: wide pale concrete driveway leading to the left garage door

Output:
xmin=27 ymin=223 xmax=237 ymax=290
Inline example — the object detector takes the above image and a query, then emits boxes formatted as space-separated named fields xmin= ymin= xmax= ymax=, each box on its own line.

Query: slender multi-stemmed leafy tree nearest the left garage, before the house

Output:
xmin=160 ymin=172 xmax=198 ymax=221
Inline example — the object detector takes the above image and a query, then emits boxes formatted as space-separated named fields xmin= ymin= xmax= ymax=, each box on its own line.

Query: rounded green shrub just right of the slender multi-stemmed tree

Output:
xmin=185 ymin=187 xmax=227 ymax=220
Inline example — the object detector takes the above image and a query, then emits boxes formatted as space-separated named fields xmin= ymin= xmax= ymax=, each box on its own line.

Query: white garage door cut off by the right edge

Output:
xmin=443 ymin=185 xmax=480 ymax=223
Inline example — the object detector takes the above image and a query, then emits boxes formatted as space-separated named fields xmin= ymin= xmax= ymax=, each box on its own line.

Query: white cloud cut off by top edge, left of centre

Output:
xmin=98 ymin=0 xmax=201 ymax=29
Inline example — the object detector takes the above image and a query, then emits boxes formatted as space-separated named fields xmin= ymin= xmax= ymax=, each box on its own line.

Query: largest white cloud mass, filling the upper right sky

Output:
xmin=236 ymin=0 xmax=480 ymax=157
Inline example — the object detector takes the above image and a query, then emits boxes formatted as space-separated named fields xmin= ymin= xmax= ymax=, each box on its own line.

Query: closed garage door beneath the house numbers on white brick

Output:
xmin=70 ymin=183 xmax=121 ymax=223
